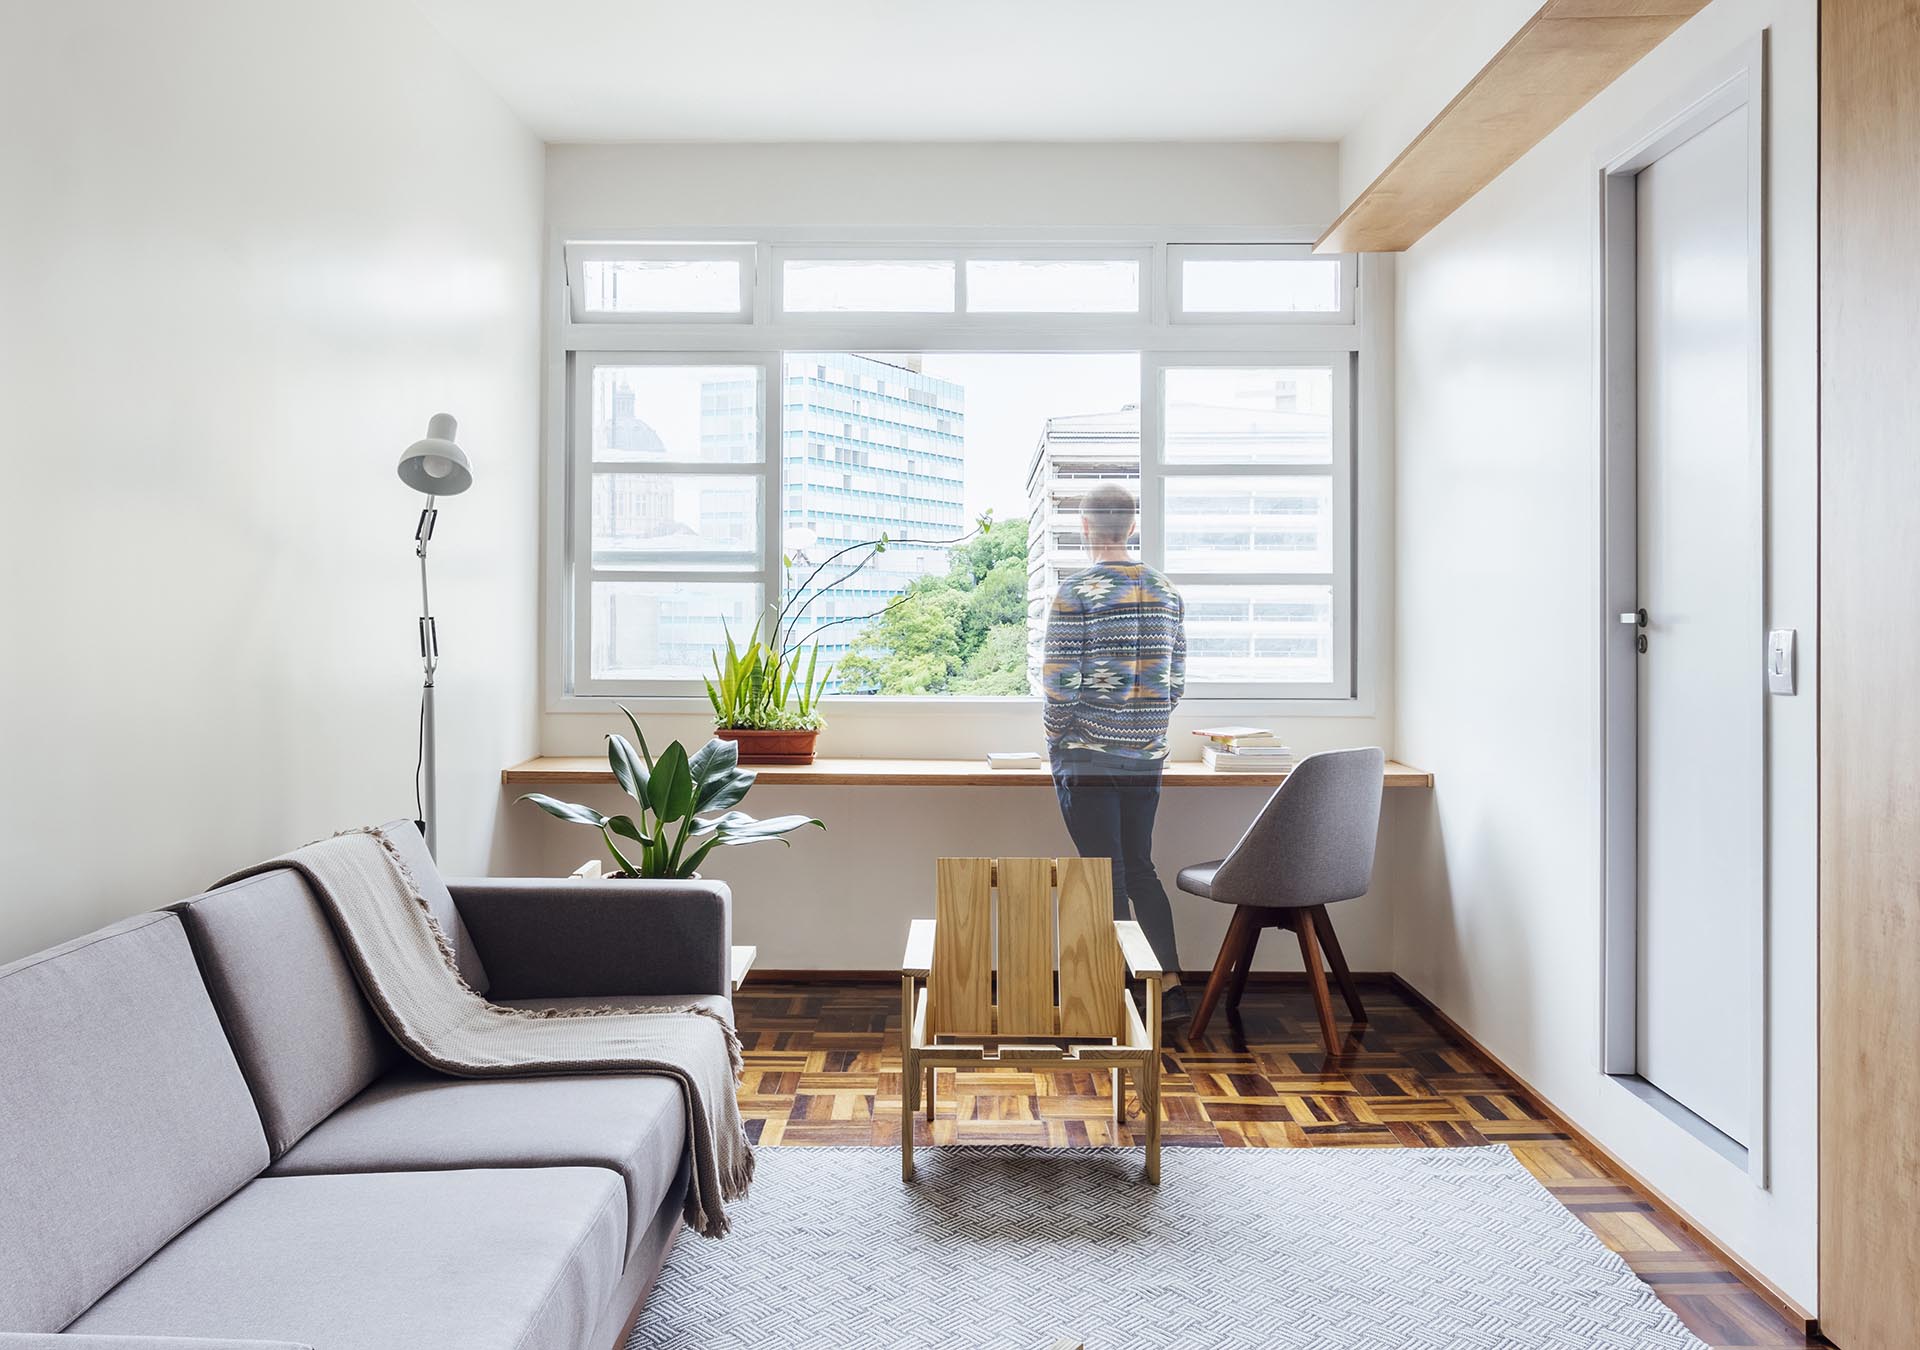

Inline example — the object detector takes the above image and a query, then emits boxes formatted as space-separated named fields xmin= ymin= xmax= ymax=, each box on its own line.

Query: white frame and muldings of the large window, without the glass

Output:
xmin=543 ymin=227 xmax=1392 ymax=716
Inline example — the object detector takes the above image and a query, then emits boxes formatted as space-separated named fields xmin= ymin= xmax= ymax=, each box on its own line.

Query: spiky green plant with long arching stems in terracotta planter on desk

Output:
xmin=705 ymin=511 xmax=993 ymax=764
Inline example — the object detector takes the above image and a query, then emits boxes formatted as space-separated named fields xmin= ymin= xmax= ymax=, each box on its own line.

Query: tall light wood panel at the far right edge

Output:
xmin=1820 ymin=0 xmax=1920 ymax=1350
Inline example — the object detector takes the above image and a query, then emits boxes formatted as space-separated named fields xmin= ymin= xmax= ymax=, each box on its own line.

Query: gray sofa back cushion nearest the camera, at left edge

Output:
xmin=0 ymin=914 xmax=267 ymax=1331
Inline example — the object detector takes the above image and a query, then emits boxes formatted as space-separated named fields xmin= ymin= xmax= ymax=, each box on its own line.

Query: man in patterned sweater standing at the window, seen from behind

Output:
xmin=1043 ymin=484 xmax=1187 ymax=993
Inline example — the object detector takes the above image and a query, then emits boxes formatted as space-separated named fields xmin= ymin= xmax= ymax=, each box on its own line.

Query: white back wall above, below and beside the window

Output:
xmin=503 ymin=144 xmax=1425 ymax=970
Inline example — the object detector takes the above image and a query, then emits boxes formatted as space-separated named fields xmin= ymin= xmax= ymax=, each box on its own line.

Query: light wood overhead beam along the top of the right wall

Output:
xmin=1313 ymin=0 xmax=1707 ymax=253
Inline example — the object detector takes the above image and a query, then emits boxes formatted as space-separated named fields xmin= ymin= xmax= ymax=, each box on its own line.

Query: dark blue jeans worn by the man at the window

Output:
xmin=1052 ymin=751 xmax=1181 ymax=972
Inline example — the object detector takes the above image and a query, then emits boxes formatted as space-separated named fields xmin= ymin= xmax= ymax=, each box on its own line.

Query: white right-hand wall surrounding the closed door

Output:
xmin=1394 ymin=0 xmax=1818 ymax=1308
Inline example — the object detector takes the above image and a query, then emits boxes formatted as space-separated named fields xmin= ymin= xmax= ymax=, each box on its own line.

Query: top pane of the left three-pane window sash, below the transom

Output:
xmin=593 ymin=365 xmax=760 ymax=465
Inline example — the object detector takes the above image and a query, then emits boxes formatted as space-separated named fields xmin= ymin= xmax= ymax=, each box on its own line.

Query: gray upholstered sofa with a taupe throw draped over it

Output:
xmin=0 ymin=824 xmax=732 ymax=1350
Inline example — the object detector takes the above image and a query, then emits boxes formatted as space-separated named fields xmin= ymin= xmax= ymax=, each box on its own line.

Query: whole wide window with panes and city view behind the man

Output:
xmin=549 ymin=238 xmax=1369 ymax=701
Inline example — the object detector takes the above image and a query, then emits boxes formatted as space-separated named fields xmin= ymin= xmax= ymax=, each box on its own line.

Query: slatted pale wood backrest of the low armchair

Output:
xmin=927 ymin=858 xmax=1127 ymax=1037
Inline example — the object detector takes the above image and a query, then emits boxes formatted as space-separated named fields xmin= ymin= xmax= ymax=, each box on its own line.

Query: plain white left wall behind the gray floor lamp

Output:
xmin=0 ymin=0 xmax=541 ymax=960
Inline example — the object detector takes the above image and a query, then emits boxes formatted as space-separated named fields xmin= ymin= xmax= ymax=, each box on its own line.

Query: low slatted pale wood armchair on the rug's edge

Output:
xmin=900 ymin=858 xmax=1160 ymax=1185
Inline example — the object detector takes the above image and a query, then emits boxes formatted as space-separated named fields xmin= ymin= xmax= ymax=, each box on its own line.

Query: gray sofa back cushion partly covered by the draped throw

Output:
xmin=175 ymin=868 xmax=401 ymax=1156
